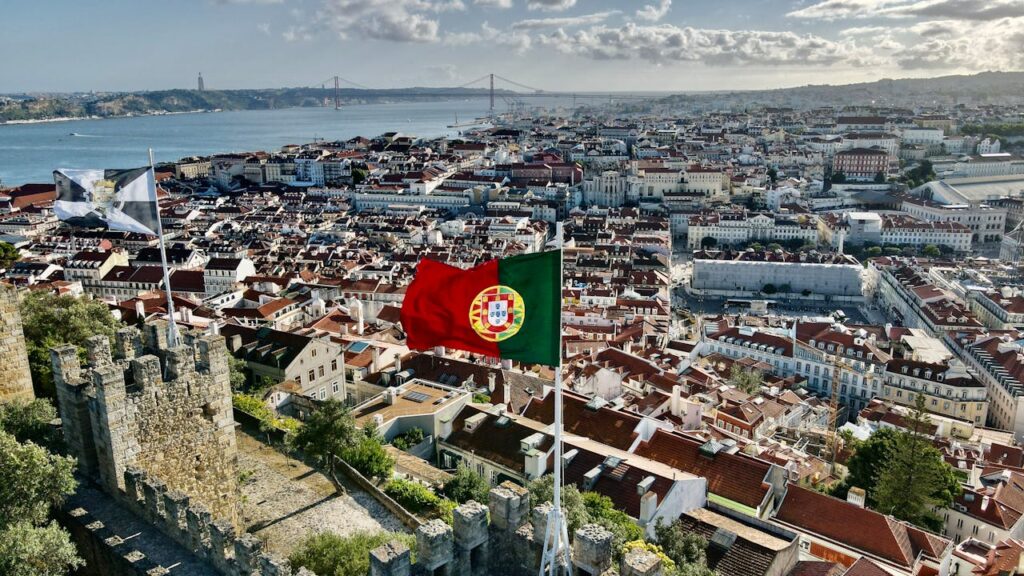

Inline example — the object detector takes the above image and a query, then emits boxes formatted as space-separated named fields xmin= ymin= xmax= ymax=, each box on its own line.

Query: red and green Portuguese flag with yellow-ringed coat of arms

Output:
xmin=401 ymin=250 xmax=561 ymax=366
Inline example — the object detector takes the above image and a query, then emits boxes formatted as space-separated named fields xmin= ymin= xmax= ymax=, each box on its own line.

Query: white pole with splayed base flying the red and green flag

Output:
xmin=541 ymin=221 xmax=572 ymax=576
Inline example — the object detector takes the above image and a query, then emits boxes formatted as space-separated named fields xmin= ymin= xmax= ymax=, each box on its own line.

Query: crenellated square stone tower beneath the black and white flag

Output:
xmin=51 ymin=322 xmax=239 ymax=527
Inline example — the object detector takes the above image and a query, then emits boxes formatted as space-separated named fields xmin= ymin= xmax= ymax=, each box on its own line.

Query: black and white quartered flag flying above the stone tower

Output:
xmin=53 ymin=167 xmax=160 ymax=236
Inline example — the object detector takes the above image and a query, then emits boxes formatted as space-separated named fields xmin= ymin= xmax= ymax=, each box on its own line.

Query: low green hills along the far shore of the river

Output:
xmin=0 ymin=88 xmax=510 ymax=123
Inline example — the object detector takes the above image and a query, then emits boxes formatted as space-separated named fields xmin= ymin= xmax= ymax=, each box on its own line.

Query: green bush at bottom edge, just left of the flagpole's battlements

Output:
xmin=288 ymin=532 xmax=416 ymax=576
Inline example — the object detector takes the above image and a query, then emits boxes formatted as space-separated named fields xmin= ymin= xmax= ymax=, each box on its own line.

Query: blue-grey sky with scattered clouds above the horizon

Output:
xmin=8 ymin=0 xmax=1024 ymax=92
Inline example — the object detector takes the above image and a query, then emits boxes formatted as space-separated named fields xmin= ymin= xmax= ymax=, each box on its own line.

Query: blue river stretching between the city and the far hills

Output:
xmin=0 ymin=97 xmax=556 ymax=186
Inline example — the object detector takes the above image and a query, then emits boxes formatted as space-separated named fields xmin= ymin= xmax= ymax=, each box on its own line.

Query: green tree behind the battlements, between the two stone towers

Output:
xmin=20 ymin=291 xmax=121 ymax=398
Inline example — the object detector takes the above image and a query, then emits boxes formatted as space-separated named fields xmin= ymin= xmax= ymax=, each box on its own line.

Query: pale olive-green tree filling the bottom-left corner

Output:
xmin=0 ymin=430 xmax=83 ymax=576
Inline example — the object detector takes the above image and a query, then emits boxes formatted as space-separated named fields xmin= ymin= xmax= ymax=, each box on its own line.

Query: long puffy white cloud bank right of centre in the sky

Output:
xmin=538 ymin=24 xmax=873 ymax=66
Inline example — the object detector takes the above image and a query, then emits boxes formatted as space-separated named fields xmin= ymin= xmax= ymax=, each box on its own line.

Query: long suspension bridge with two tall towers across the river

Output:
xmin=310 ymin=74 xmax=652 ymax=113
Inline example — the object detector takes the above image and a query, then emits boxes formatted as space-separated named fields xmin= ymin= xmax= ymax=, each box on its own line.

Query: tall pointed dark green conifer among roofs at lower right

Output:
xmin=874 ymin=394 xmax=961 ymax=531
